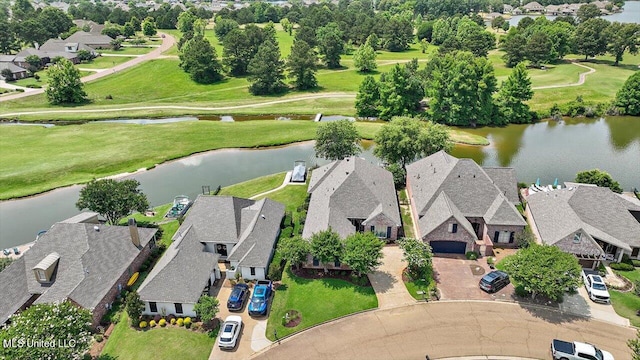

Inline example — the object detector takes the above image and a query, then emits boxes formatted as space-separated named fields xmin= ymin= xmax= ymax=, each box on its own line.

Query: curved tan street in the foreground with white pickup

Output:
xmin=253 ymin=301 xmax=635 ymax=360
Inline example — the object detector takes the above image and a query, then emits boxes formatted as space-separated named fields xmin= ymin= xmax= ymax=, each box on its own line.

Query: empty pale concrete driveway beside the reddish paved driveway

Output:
xmin=369 ymin=245 xmax=416 ymax=309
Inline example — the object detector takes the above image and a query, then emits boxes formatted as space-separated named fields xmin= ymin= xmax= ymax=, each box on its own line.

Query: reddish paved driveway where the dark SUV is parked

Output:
xmin=433 ymin=255 xmax=514 ymax=301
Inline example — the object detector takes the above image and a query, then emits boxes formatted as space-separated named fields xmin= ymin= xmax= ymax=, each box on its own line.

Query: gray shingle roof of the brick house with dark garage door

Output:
xmin=407 ymin=151 xmax=526 ymax=236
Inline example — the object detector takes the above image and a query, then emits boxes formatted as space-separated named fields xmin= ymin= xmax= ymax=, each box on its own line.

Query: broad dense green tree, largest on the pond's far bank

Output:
xmin=426 ymin=52 xmax=497 ymax=126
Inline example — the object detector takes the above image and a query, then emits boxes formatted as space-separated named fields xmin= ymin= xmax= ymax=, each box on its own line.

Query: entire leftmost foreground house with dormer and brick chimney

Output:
xmin=0 ymin=213 xmax=157 ymax=327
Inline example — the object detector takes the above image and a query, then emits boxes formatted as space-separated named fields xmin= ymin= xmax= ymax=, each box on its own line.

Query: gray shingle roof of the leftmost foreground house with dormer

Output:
xmin=0 ymin=223 xmax=157 ymax=321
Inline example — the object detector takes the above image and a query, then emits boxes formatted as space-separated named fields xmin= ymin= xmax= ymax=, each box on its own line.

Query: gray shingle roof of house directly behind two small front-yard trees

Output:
xmin=302 ymin=157 xmax=401 ymax=238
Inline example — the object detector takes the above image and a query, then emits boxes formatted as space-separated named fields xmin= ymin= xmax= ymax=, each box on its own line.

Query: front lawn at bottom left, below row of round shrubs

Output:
xmin=102 ymin=312 xmax=216 ymax=360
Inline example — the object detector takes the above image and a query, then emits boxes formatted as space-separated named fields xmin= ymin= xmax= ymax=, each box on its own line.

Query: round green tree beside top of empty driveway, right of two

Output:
xmin=342 ymin=232 xmax=384 ymax=276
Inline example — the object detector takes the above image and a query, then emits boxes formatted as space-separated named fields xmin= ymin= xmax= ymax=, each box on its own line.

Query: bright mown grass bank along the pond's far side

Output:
xmin=0 ymin=120 xmax=486 ymax=200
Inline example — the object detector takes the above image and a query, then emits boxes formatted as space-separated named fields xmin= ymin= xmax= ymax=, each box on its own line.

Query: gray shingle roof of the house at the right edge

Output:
xmin=528 ymin=186 xmax=640 ymax=251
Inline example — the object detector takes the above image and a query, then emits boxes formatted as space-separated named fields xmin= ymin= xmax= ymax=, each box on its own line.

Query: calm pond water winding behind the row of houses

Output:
xmin=0 ymin=117 xmax=640 ymax=248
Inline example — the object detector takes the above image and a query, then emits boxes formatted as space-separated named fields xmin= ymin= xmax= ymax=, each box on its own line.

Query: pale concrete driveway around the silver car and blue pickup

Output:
xmin=209 ymin=281 xmax=271 ymax=360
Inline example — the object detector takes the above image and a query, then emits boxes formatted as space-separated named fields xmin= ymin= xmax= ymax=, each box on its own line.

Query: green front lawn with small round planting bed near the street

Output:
xmin=266 ymin=266 xmax=378 ymax=340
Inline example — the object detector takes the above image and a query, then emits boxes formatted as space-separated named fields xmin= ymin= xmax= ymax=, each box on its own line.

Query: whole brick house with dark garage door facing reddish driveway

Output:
xmin=407 ymin=151 xmax=526 ymax=255
